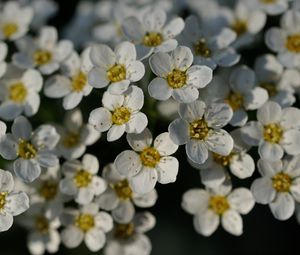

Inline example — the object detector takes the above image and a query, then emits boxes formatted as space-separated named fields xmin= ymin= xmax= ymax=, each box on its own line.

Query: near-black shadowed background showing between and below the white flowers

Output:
xmin=0 ymin=0 xmax=300 ymax=255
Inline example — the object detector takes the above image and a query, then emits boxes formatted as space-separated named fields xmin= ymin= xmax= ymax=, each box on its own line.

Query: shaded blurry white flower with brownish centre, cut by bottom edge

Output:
xmin=104 ymin=212 xmax=156 ymax=255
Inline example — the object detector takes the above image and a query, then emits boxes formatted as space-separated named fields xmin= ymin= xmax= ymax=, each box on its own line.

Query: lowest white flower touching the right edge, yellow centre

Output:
xmin=251 ymin=156 xmax=300 ymax=220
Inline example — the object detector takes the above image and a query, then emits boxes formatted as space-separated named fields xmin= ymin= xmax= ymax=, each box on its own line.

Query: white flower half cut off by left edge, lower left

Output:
xmin=0 ymin=169 xmax=29 ymax=232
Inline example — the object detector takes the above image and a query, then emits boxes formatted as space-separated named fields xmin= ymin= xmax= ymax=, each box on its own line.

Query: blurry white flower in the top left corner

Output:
xmin=0 ymin=1 xmax=33 ymax=41
